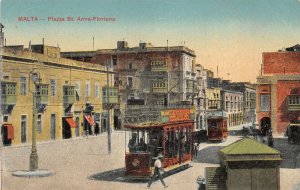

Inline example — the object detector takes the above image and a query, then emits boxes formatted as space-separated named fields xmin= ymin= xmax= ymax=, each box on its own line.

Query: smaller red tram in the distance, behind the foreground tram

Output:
xmin=207 ymin=117 xmax=228 ymax=141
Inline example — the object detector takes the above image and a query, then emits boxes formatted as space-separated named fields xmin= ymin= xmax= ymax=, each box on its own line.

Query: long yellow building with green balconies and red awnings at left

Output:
xmin=1 ymin=44 xmax=118 ymax=144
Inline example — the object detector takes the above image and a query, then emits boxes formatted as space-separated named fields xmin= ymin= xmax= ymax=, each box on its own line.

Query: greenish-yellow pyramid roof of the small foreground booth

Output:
xmin=220 ymin=137 xmax=280 ymax=155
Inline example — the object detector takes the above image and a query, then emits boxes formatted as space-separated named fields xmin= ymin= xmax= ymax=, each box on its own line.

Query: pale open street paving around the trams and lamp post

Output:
xmin=2 ymin=132 xmax=300 ymax=190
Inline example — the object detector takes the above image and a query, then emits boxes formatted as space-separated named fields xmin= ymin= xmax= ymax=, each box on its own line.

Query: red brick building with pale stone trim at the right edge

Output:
xmin=256 ymin=46 xmax=300 ymax=133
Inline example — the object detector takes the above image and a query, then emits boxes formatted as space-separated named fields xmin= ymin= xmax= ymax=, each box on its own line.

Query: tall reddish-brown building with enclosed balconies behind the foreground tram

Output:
xmin=81 ymin=41 xmax=198 ymax=131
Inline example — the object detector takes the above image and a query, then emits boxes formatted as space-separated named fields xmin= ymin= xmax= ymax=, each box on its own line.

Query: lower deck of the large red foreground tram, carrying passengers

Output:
xmin=124 ymin=120 xmax=194 ymax=178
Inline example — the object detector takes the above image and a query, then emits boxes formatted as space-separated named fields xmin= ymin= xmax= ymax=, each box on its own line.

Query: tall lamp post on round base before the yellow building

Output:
xmin=29 ymin=71 xmax=40 ymax=171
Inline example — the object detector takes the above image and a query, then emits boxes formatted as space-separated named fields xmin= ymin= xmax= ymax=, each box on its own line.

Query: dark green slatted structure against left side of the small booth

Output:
xmin=205 ymin=167 xmax=226 ymax=190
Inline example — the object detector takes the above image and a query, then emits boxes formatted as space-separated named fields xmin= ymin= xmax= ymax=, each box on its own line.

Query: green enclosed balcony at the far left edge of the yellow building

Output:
xmin=1 ymin=81 xmax=17 ymax=105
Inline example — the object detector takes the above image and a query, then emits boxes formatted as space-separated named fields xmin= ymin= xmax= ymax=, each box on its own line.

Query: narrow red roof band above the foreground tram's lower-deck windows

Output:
xmin=124 ymin=120 xmax=194 ymax=129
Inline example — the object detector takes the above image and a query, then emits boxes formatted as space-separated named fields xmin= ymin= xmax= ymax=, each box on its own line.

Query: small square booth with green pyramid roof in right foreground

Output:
xmin=219 ymin=138 xmax=282 ymax=190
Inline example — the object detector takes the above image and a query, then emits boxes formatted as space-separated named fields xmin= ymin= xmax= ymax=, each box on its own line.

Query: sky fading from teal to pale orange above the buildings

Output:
xmin=1 ymin=0 xmax=300 ymax=82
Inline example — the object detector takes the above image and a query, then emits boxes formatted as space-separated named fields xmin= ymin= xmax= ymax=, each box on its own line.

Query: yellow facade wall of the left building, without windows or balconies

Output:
xmin=1 ymin=48 xmax=113 ymax=144
